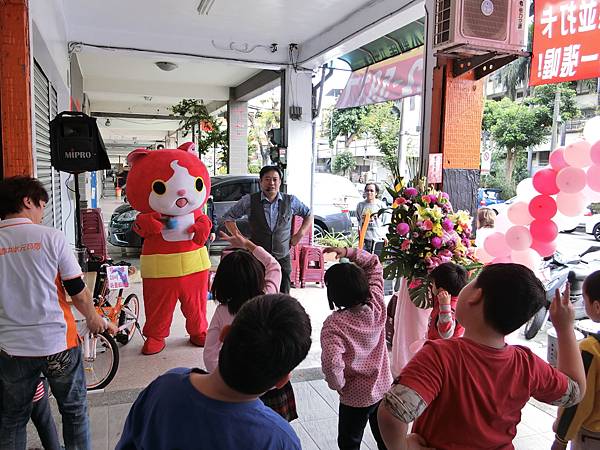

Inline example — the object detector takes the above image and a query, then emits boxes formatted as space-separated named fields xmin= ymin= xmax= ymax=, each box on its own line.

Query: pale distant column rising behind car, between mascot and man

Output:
xmin=227 ymin=101 xmax=248 ymax=175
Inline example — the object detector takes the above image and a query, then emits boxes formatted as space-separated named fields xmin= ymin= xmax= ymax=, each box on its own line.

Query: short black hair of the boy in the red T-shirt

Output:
xmin=475 ymin=263 xmax=546 ymax=336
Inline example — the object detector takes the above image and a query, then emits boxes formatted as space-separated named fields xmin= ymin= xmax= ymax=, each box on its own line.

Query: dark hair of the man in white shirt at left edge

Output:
xmin=0 ymin=176 xmax=49 ymax=220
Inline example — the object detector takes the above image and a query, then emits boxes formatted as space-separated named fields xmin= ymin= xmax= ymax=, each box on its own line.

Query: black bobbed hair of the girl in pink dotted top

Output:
xmin=325 ymin=263 xmax=369 ymax=310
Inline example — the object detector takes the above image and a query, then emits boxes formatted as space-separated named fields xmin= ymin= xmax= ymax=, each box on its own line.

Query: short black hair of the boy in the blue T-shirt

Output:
xmin=219 ymin=294 xmax=312 ymax=395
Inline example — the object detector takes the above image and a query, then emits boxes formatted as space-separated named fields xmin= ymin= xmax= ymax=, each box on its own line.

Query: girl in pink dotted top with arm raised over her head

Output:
xmin=321 ymin=248 xmax=392 ymax=449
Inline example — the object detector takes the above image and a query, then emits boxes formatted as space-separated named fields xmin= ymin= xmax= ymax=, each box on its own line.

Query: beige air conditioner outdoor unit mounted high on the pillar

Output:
xmin=433 ymin=0 xmax=526 ymax=56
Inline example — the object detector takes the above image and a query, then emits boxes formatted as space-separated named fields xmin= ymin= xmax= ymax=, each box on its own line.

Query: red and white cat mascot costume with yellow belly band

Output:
xmin=127 ymin=142 xmax=211 ymax=355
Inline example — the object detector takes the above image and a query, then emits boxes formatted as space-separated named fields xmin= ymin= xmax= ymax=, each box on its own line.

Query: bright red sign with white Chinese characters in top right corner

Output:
xmin=530 ymin=0 xmax=600 ymax=86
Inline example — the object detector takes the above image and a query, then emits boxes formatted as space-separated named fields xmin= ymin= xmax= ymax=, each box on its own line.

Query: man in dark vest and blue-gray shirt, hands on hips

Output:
xmin=223 ymin=166 xmax=313 ymax=294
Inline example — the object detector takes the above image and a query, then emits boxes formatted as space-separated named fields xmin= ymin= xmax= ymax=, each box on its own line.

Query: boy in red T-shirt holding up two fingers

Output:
xmin=378 ymin=264 xmax=585 ymax=450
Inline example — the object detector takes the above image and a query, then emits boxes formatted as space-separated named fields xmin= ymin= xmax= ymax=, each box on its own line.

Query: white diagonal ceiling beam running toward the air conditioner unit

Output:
xmin=298 ymin=0 xmax=425 ymax=68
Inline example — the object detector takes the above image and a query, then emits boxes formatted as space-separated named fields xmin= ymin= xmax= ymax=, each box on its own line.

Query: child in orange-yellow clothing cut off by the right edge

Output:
xmin=552 ymin=270 xmax=600 ymax=450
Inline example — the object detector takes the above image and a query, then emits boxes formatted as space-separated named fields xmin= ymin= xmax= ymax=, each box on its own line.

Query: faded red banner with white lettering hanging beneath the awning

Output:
xmin=335 ymin=46 xmax=423 ymax=109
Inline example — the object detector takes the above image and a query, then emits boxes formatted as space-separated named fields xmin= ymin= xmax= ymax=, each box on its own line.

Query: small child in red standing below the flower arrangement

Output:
xmin=427 ymin=262 xmax=468 ymax=339
